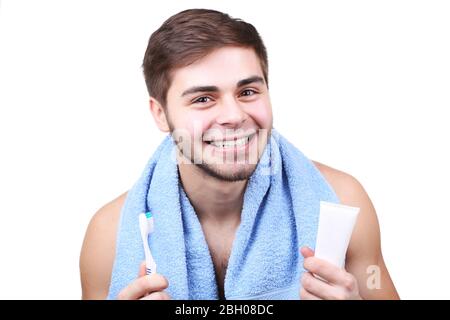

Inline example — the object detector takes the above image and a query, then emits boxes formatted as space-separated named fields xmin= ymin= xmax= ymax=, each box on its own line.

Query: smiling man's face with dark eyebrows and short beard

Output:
xmin=166 ymin=47 xmax=272 ymax=181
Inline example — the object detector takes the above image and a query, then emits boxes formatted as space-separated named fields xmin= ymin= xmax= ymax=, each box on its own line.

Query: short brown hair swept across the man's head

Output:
xmin=142 ymin=9 xmax=268 ymax=107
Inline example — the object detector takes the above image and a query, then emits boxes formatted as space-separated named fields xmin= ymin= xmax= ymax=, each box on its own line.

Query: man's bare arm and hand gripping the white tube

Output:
xmin=301 ymin=163 xmax=399 ymax=299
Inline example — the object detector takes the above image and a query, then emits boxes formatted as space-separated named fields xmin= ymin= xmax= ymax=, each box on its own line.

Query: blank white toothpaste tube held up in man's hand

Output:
xmin=314 ymin=201 xmax=359 ymax=268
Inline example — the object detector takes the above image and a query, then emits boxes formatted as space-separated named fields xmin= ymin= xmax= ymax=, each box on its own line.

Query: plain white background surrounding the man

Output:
xmin=0 ymin=0 xmax=450 ymax=299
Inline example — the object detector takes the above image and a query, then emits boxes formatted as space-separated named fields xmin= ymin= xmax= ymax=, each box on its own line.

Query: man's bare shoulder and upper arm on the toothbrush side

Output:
xmin=80 ymin=192 xmax=127 ymax=299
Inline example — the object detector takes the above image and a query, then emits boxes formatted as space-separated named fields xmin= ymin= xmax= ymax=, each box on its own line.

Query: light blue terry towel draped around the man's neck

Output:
xmin=108 ymin=129 xmax=339 ymax=300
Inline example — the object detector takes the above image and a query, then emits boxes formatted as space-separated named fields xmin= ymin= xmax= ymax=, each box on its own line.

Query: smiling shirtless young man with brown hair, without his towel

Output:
xmin=80 ymin=9 xmax=398 ymax=299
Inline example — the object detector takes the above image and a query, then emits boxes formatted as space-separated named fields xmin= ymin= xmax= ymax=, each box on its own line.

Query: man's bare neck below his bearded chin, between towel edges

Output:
xmin=178 ymin=163 xmax=247 ymax=225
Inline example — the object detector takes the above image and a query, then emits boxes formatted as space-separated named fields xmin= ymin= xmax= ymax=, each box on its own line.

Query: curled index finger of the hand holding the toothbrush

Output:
xmin=118 ymin=273 xmax=169 ymax=300
